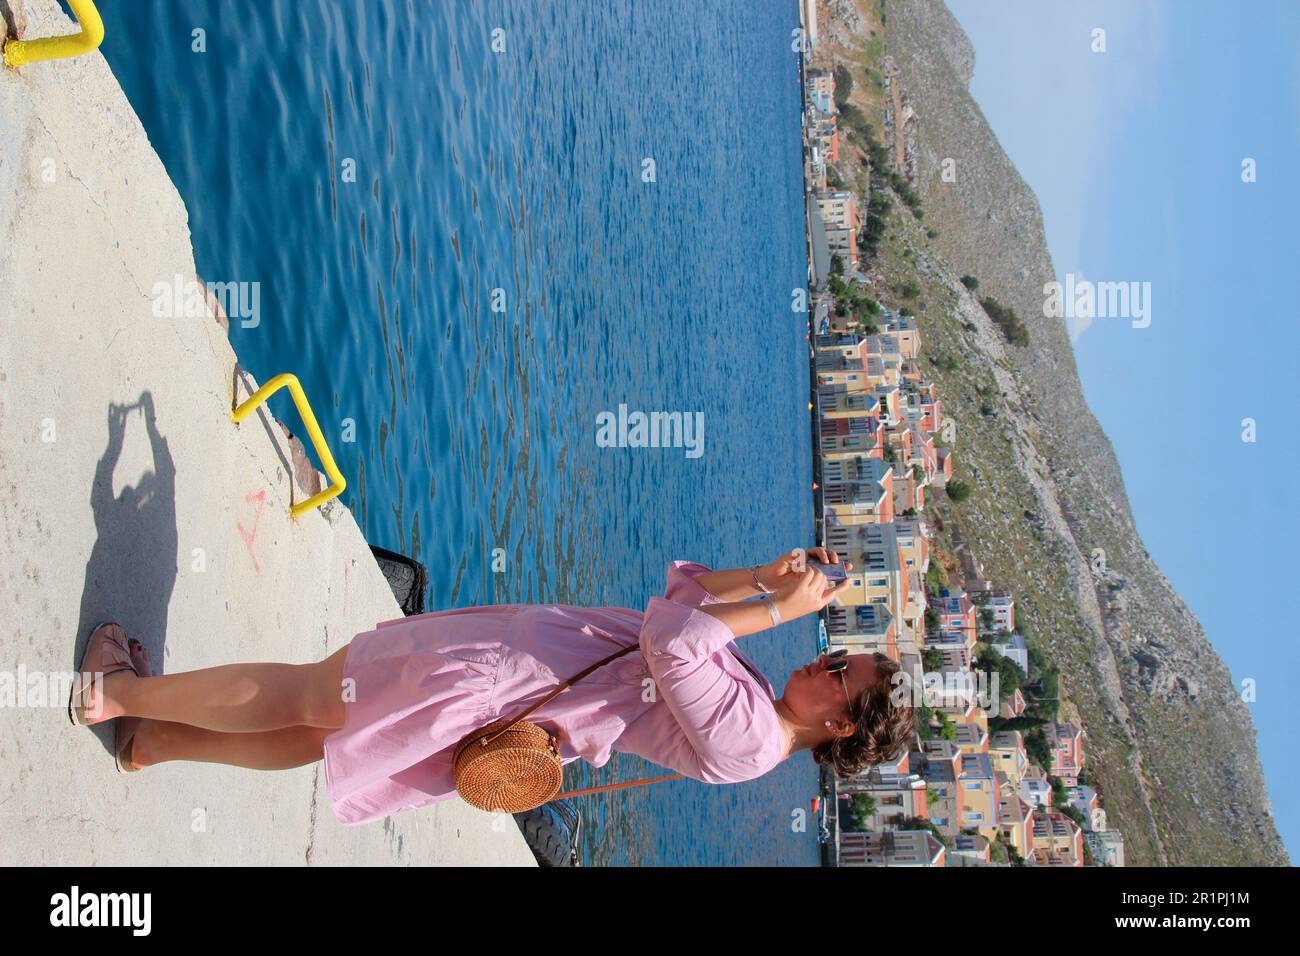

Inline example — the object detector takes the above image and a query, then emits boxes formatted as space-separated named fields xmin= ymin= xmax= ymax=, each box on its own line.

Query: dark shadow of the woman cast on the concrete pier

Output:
xmin=70 ymin=392 xmax=178 ymax=745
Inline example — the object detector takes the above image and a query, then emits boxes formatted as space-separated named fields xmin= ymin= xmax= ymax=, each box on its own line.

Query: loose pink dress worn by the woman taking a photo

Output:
xmin=325 ymin=561 xmax=785 ymax=823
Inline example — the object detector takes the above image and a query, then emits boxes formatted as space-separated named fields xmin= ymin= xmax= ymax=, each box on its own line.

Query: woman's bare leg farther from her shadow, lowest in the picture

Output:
xmin=131 ymin=721 xmax=334 ymax=770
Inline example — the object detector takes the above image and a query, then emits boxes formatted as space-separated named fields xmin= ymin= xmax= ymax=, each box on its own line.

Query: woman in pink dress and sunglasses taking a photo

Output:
xmin=69 ymin=548 xmax=915 ymax=823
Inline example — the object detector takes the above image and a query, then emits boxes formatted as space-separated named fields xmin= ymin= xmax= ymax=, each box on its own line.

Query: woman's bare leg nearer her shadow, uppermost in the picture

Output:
xmin=104 ymin=645 xmax=347 ymax=734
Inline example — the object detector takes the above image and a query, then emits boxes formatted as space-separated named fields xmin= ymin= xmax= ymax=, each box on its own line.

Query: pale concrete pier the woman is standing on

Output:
xmin=0 ymin=0 xmax=533 ymax=865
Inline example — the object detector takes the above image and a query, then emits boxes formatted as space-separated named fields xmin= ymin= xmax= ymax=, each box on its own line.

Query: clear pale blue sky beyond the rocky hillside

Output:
xmin=946 ymin=0 xmax=1300 ymax=860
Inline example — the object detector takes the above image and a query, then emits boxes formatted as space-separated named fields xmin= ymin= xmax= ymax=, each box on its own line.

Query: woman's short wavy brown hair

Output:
xmin=813 ymin=652 xmax=917 ymax=779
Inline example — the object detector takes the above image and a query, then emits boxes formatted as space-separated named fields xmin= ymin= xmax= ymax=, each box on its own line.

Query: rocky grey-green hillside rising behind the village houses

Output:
xmin=820 ymin=0 xmax=1288 ymax=865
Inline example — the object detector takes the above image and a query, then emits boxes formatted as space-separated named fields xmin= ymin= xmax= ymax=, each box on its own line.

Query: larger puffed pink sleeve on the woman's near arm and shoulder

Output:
xmin=641 ymin=598 xmax=785 ymax=783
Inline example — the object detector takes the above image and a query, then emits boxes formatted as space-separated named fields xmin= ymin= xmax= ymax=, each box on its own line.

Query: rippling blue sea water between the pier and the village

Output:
xmin=101 ymin=0 xmax=818 ymax=865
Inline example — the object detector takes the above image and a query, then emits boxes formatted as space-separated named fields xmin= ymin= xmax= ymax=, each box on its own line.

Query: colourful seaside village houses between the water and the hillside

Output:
xmin=805 ymin=63 xmax=1123 ymax=866
